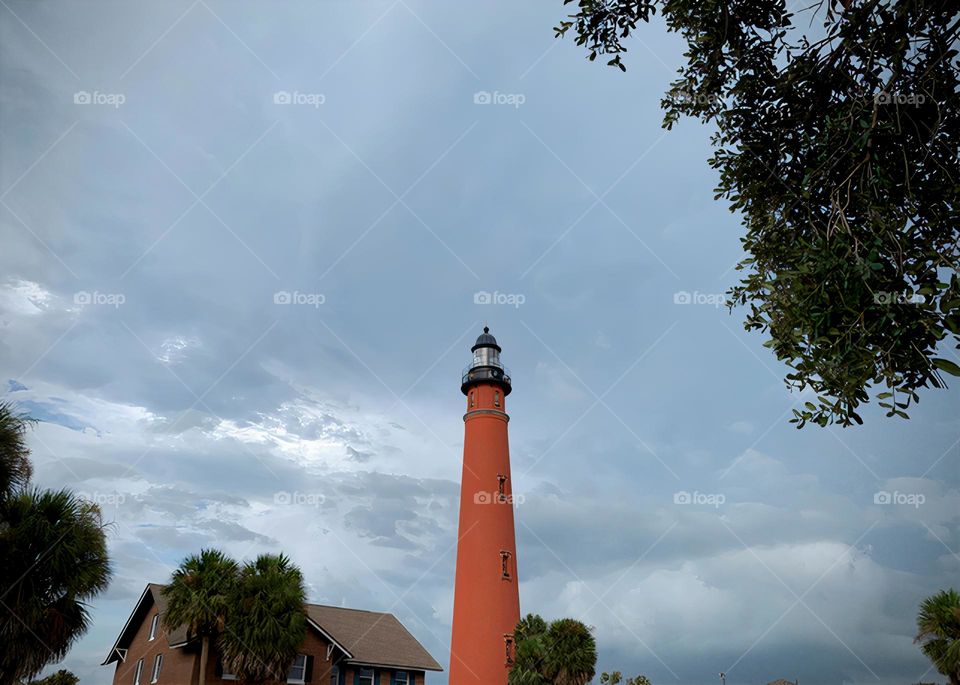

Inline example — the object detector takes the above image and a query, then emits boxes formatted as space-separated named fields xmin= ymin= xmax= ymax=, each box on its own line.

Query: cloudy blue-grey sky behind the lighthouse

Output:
xmin=0 ymin=0 xmax=960 ymax=685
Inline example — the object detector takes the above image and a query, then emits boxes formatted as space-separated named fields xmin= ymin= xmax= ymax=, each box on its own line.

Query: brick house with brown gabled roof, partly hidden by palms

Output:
xmin=103 ymin=583 xmax=443 ymax=685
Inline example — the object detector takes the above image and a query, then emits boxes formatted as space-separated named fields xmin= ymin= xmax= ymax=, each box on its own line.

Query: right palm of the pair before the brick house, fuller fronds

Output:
xmin=220 ymin=554 xmax=307 ymax=682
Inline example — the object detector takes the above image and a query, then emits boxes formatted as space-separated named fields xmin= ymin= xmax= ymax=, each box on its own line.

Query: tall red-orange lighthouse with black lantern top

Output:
xmin=450 ymin=327 xmax=520 ymax=685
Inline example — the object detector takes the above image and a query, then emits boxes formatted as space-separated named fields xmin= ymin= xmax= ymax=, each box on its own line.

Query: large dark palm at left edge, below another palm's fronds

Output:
xmin=0 ymin=489 xmax=110 ymax=685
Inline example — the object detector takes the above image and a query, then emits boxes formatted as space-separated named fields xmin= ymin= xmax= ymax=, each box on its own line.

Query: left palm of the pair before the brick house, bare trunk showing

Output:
xmin=162 ymin=549 xmax=239 ymax=685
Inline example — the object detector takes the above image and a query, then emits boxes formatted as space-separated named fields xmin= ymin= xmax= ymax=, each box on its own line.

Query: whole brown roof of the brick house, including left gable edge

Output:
xmin=102 ymin=583 xmax=443 ymax=671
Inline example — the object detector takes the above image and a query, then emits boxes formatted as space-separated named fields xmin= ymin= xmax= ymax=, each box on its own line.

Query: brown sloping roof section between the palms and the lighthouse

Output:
xmin=307 ymin=604 xmax=443 ymax=671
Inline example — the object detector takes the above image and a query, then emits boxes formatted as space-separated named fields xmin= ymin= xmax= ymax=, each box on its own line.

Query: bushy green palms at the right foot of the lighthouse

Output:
xmin=508 ymin=614 xmax=597 ymax=685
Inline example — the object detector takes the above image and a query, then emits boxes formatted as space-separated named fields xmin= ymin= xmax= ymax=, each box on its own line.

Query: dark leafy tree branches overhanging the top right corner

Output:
xmin=555 ymin=0 xmax=960 ymax=427
